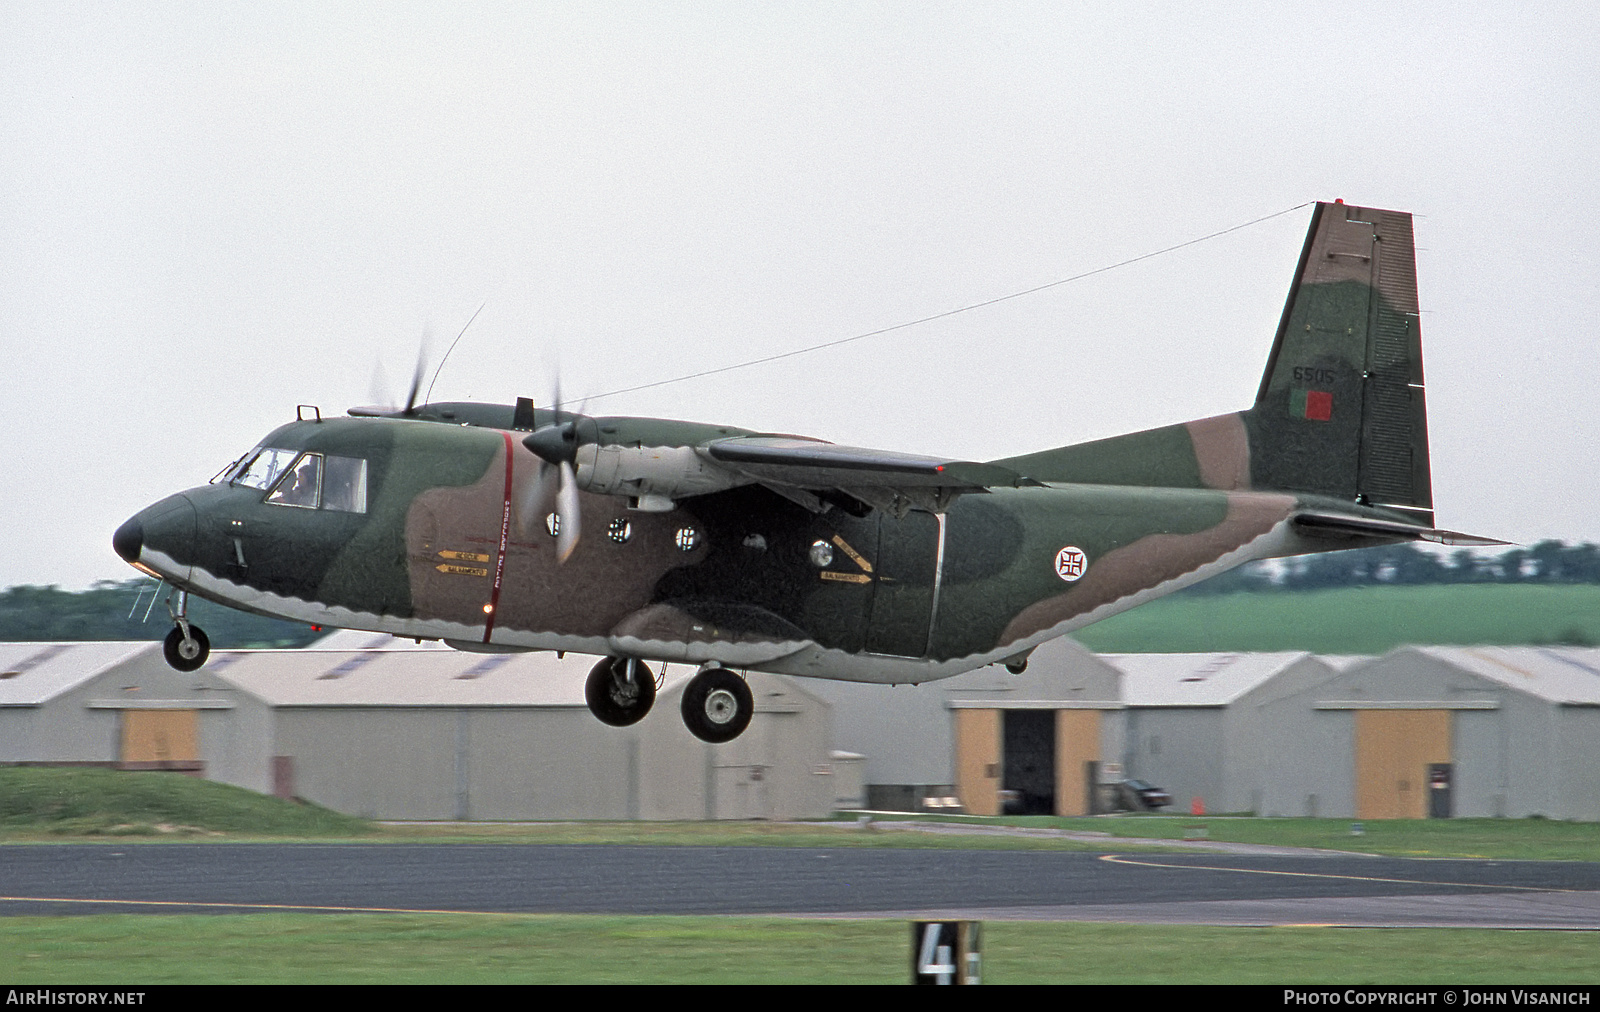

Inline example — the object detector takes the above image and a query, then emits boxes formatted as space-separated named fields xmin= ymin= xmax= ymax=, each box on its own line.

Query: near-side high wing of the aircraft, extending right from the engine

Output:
xmin=699 ymin=436 xmax=1038 ymax=516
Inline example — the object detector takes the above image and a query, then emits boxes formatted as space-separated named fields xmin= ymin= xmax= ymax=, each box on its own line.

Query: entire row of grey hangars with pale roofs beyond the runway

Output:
xmin=9 ymin=633 xmax=1600 ymax=820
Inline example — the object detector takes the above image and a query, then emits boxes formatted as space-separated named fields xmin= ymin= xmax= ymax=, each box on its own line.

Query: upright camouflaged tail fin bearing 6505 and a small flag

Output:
xmin=1243 ymin=203 xmax=1434 ymax=527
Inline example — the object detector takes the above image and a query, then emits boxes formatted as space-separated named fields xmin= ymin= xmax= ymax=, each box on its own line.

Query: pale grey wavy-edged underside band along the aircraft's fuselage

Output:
xmin=139 ymin=520 xmax=1307 ymax=685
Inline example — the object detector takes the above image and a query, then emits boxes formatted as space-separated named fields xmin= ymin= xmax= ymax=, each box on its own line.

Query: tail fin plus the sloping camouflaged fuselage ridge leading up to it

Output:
xmin=995 ymin=203 xmax=1434 ymax=527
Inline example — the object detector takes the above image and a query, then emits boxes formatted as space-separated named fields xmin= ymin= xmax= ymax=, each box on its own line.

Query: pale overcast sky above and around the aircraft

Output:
xmin=0 ymin=0 xmax=1600 ymax=588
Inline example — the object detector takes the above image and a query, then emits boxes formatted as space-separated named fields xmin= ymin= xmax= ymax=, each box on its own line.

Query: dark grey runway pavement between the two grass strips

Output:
xmin=0 ymin=844 xmax=1600 ymax=930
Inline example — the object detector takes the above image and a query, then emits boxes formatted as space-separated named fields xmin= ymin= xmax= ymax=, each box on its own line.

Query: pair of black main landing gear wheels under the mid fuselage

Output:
xmin=585 ymin=656 xmax=755 ymax=745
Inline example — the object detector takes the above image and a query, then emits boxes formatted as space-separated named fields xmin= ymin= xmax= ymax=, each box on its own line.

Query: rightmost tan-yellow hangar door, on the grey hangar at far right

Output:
xmin=1355 ymin=709 xmax=1450 ymax=818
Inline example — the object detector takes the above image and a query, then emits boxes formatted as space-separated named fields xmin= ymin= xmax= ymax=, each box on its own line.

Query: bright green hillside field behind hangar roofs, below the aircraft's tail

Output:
xmin=1074 ymin=584 xmax=1600 ymax=653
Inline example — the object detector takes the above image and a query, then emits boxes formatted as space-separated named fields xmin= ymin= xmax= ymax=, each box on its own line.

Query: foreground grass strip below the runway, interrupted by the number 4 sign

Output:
xmin=0 ymin=914 xmax=1600 ymax=988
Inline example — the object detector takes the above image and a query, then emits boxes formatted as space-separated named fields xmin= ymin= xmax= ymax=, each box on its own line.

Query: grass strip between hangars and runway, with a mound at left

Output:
xmin=9 ymin=767 xmax=1600 ymax=861
